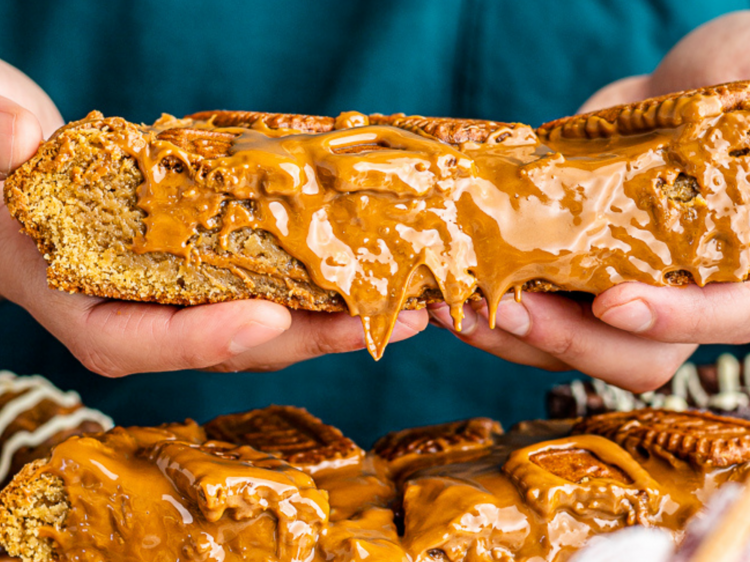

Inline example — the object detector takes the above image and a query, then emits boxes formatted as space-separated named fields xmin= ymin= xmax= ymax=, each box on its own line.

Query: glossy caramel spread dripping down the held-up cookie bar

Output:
xmin=104 ymin=83 xmax=750 ymax=358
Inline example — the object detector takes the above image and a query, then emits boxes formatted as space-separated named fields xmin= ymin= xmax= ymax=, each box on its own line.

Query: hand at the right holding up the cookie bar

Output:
xmin=430 ymin=11 xmax=750 ymax=392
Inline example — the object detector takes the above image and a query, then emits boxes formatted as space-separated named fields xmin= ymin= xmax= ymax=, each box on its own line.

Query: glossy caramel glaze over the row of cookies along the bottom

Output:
xmin=7 ymin=407 xmax=748 ymax=562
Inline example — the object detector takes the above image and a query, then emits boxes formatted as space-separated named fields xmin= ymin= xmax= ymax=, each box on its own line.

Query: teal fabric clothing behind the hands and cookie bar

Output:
xmin=0 ymin=0 xmax=750 ymax=444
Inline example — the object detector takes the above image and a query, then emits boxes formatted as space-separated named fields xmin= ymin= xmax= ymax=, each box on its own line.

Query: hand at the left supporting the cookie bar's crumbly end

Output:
xmin=0 ymin=61 xmax=427 ymax=377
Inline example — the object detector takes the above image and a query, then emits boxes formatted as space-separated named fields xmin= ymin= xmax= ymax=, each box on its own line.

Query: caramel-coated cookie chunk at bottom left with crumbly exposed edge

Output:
xmin=0 ymin=422 xmax=329 ymax=562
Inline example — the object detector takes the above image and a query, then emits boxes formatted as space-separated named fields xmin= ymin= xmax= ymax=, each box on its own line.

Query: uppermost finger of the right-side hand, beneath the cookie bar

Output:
xmin=593 ymin=282 xmax=750 ymax=344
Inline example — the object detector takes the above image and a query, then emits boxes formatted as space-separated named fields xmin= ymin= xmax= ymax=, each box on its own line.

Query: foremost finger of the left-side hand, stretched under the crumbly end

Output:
xmin=70 ymin=300 xmax=291 ymax=377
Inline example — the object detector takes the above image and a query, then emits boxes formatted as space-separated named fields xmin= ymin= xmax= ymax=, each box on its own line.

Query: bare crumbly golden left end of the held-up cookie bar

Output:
xmin=5 ymin=117 xmax=343 ymax=311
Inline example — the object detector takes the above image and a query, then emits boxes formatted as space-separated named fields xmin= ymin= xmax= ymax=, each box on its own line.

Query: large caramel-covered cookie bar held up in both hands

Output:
xmin=5 ymin=82 xmax=750 ymax=358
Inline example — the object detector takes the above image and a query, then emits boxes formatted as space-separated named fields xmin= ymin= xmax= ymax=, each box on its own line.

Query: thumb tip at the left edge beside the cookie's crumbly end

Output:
xmin=0 ymin=97 xmax=42 ymax=179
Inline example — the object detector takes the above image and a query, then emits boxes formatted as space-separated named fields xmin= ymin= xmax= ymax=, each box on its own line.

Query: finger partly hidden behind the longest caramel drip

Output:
xmin=211 ymin=310 xmax=428 ymax=371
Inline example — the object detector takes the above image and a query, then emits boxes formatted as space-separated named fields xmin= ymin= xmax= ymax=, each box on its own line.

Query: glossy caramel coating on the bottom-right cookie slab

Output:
xmin=402 ymin=428 xmax=743 ymax=562
